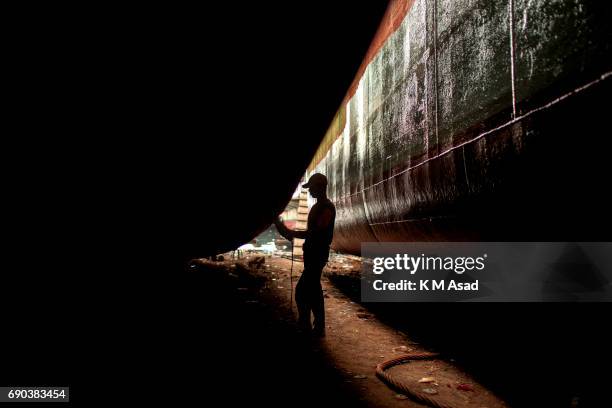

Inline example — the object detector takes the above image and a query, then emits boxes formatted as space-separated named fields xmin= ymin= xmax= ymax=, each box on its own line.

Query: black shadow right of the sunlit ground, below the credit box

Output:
xmin=329 ymin=275 xmax=612 ymax=407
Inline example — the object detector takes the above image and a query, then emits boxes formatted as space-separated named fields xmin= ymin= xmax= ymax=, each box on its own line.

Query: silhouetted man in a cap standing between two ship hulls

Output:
xmin=274 ymin=173 xmax=336 ymax=336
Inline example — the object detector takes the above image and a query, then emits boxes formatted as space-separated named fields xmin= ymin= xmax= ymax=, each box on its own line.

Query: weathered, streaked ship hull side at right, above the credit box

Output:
xmin=309 ymin=0 xmax=612 ymax=253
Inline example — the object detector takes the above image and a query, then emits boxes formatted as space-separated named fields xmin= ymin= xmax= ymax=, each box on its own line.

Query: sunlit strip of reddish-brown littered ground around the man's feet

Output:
xmin=195 ymin=254 xmax=505 ymax=408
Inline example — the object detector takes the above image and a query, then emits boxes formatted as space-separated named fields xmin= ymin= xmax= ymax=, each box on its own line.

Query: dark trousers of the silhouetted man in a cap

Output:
xmin=295 ymin=254 xmax=327 ymax=332
